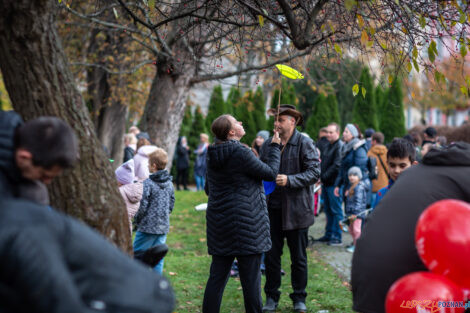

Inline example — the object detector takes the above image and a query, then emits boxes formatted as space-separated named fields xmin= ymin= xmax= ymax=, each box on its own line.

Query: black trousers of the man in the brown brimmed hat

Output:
xmin=264 ymin=210 xmax=308 ymax=303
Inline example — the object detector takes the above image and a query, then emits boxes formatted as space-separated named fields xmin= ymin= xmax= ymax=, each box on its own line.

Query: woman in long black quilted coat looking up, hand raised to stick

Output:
xmin=202 ymin=115 xmax=281 ymax=313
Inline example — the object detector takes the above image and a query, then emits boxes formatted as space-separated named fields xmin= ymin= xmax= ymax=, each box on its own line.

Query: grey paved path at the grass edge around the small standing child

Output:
xmin=309 ymin=213 xmax=352 ymax=282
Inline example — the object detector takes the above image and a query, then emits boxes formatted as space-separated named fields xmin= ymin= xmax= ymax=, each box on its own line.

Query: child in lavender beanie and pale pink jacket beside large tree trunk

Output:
xmin=115 ymin=159 xmax=143 ymax=234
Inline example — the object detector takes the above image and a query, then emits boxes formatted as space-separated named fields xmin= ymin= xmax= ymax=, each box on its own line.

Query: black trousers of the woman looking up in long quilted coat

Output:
xmin=202 ymin=254 xmax=263 ymax=313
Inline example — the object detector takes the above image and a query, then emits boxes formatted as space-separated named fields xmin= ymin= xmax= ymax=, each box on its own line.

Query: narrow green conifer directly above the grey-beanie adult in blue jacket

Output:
xmin=353 ymin=68 xmax=378 ymax=132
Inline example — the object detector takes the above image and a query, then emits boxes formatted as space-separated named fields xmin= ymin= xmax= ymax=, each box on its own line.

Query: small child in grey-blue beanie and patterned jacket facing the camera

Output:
xmin=344 ymin=166 xmax=367 ymax=253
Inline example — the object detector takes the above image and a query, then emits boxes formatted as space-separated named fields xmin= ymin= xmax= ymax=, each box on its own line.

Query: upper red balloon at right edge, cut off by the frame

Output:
xmin=415 ymin=200 xmax=470 ymax=289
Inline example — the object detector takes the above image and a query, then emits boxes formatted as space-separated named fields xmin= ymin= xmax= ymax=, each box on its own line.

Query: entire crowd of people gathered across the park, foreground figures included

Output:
xmin=0 ymin=105 xmax=470 ymax=313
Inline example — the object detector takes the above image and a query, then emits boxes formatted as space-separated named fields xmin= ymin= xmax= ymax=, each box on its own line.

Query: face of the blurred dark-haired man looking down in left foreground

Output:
xmin=15 ymin=149 xmax=63 ymax=185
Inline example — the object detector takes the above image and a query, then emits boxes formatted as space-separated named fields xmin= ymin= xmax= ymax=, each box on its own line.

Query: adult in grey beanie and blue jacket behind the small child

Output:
xmin=334 ymin=124 xmax=371 ymax=246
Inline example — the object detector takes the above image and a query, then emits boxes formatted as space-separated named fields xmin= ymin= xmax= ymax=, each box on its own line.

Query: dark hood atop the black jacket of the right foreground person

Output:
xmin=423 ymin=141 xmax=470 ymax=166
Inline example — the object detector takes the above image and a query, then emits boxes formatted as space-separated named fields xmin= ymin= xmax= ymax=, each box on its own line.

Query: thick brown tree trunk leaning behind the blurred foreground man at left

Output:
xmin=0 ymin=0 xmax=131 ymax=251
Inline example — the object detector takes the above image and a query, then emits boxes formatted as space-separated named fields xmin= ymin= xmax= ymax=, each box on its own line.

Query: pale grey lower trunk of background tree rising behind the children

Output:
xmin=140 ymin=65 xmax=191 ymax=169
